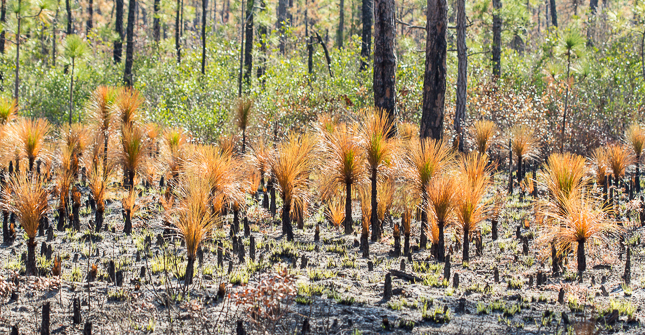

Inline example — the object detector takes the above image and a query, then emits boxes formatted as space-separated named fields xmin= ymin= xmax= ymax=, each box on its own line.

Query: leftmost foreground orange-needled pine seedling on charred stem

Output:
xmin=0 ymin=171 xmax=49 ymax=276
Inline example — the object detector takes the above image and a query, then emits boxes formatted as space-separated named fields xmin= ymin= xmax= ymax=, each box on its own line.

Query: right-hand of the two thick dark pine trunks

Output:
xmin=420 ymin=0 xmax=448 ymax=139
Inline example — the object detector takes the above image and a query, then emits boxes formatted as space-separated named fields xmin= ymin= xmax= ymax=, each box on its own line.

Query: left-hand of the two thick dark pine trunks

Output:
xmin=373 ymin=0 xmax=396 ymax=122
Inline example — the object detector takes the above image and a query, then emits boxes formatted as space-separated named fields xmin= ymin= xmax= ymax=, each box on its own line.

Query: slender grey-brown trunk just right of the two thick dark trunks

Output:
xmin=455 ymin=0 xmax=468 ymax=152
